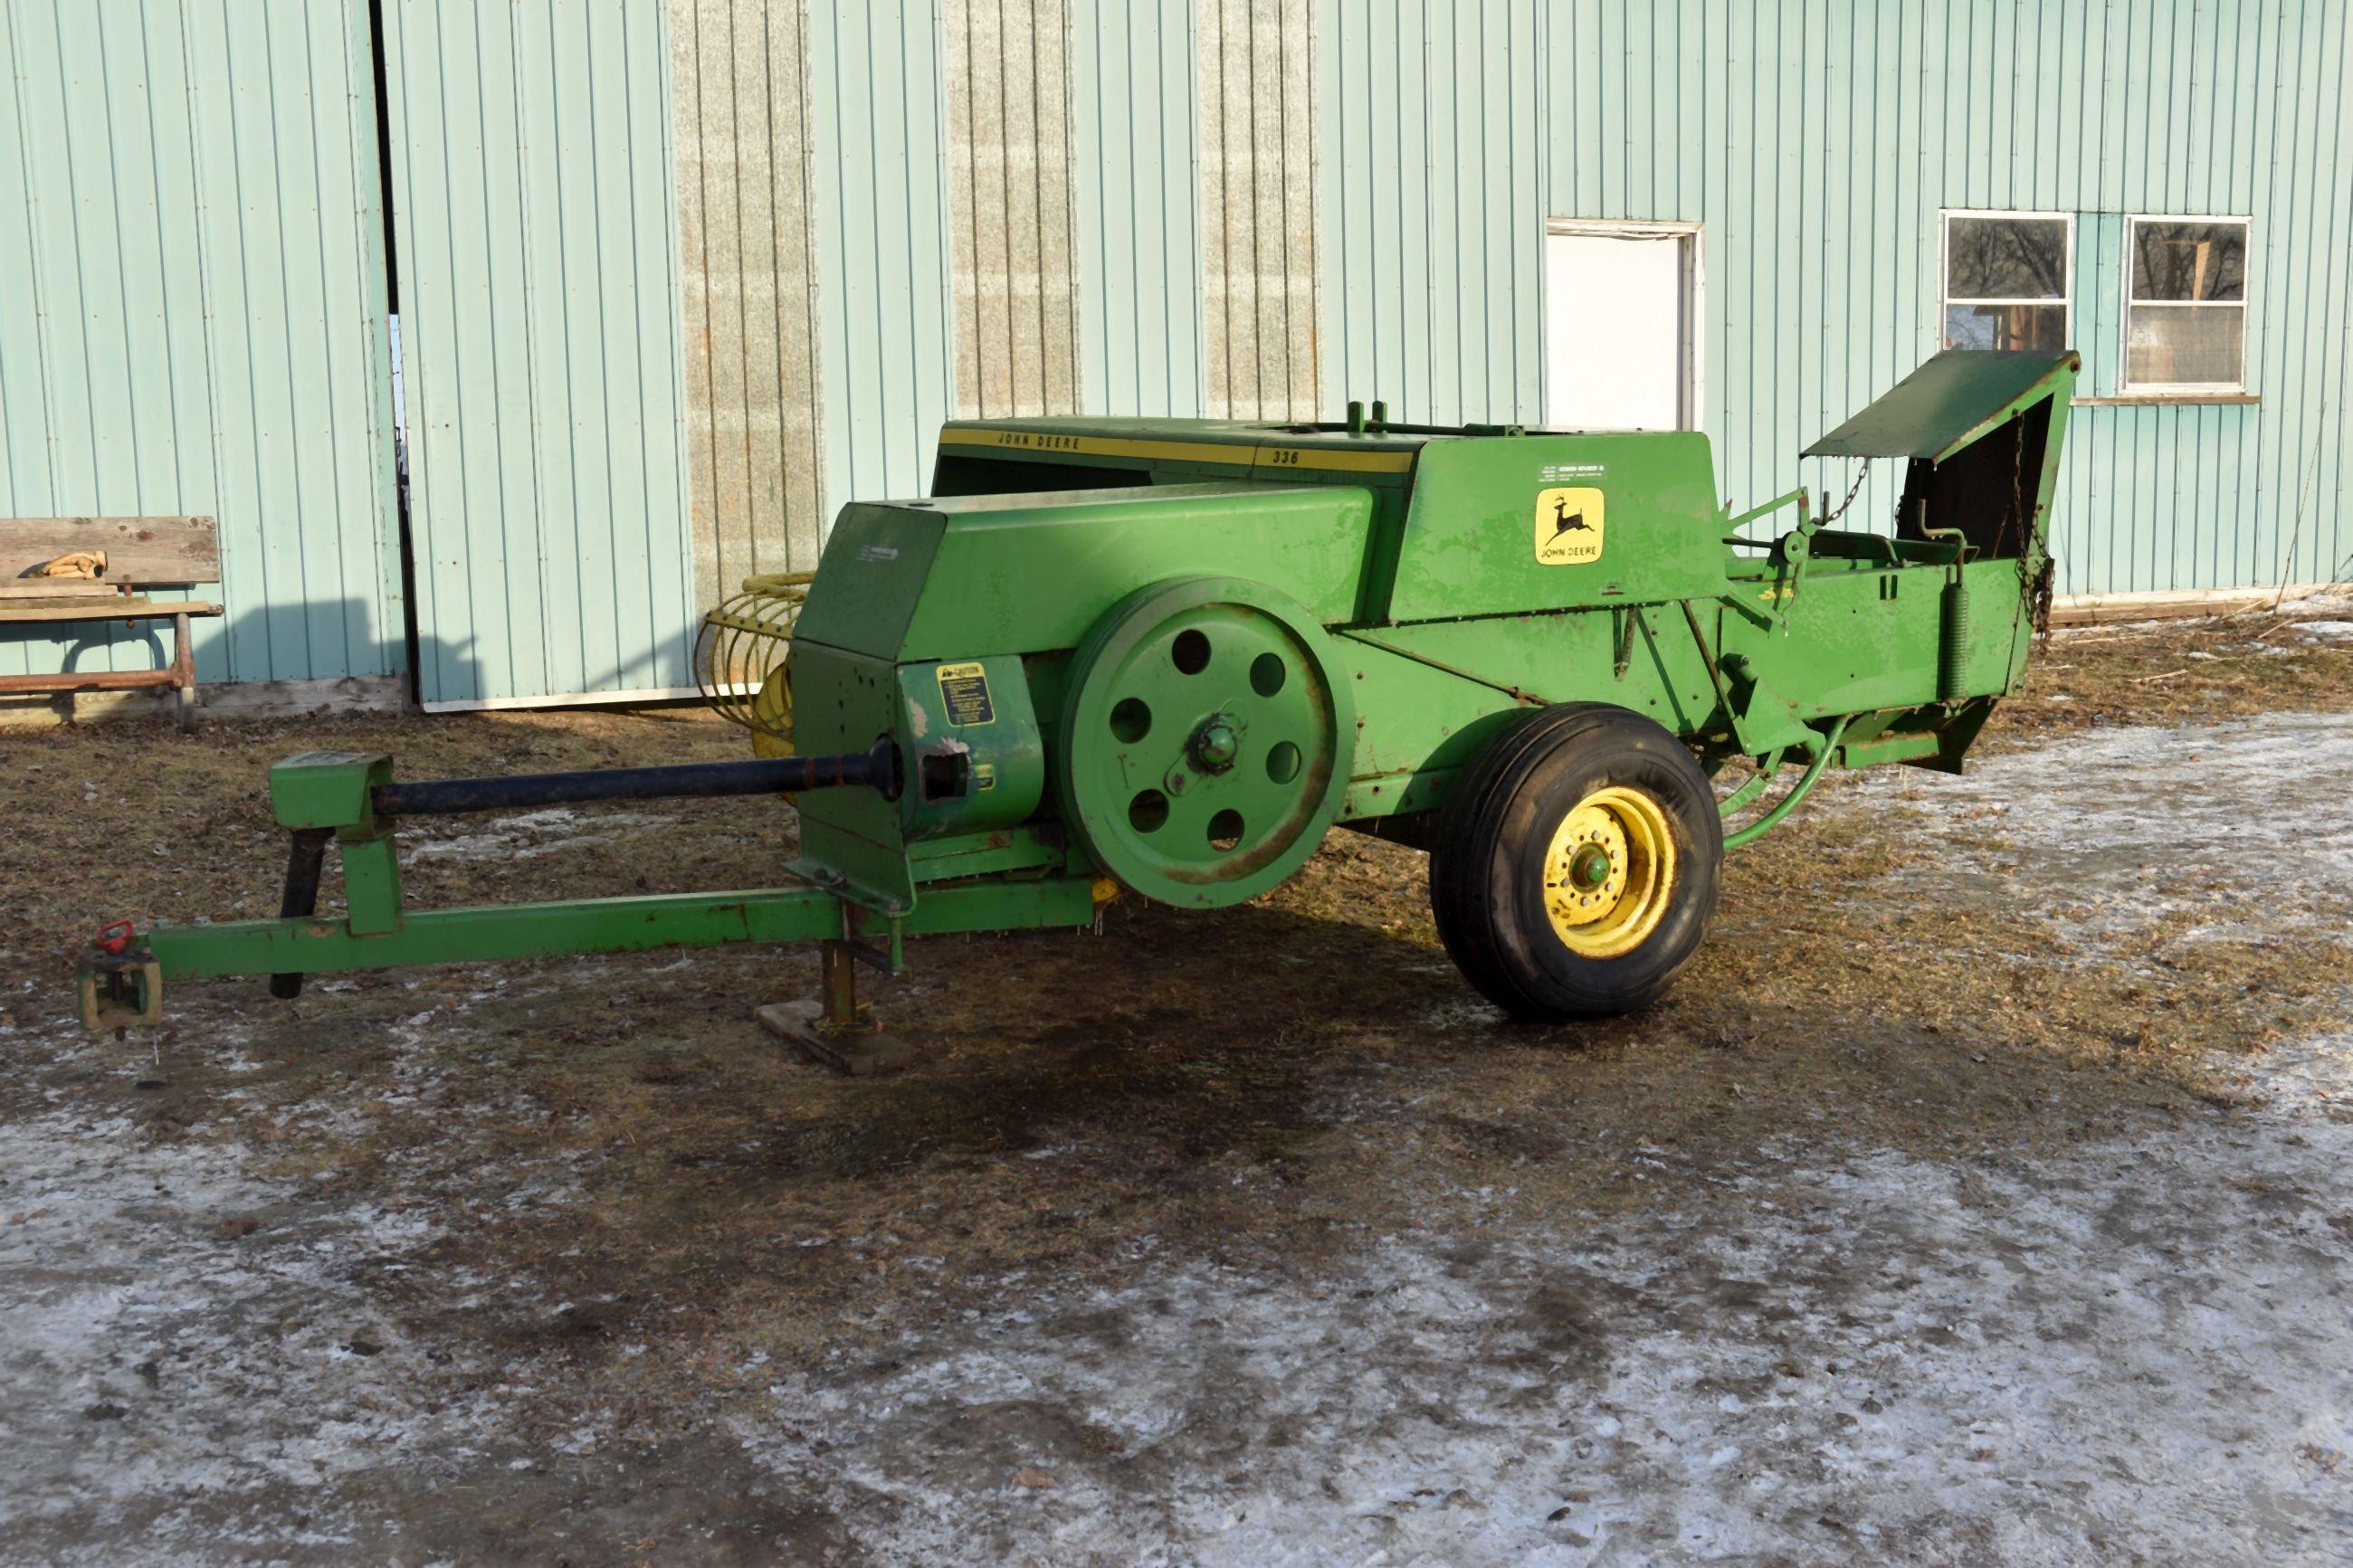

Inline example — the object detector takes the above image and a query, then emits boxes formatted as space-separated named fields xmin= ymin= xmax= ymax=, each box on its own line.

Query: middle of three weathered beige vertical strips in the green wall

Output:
xmin=941 ymin=0 xmax=1080 ymax=418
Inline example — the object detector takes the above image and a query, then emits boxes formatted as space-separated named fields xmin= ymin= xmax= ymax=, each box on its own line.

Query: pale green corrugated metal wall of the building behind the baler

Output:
xmin=0 ymin=0 xmax=2353 ymax=700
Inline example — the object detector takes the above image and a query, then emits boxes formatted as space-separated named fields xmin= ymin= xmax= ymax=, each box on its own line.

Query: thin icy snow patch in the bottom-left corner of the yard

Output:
xmin=0 ymin=1041 xmax=529 ymax=1563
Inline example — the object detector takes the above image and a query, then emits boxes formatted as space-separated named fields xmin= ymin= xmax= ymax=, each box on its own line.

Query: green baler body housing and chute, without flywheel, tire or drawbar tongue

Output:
xmin=793 ymin=345 xmax=2073 ymax=912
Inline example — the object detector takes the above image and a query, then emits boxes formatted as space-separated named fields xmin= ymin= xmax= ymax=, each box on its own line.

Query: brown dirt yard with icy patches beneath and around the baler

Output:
xmin=0 ymin=602 xmax=2353 ymax=1563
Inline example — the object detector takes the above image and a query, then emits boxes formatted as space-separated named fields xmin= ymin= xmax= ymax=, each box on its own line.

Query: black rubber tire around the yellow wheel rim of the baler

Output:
xmin=1431 ymin=703 xmax=1725 ymax=1022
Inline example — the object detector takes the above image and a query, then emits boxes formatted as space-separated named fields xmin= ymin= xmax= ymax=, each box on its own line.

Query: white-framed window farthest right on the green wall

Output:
xmin=2122 ymin=214 xmax=2252 ymax=393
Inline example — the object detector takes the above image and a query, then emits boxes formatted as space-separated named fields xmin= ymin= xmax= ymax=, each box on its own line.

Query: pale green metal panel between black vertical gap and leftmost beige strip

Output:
xmin=384 ymin=0 xmax=697 ymax=708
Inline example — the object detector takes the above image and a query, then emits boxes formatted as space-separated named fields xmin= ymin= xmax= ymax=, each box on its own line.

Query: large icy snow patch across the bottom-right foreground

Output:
xmin=738 ymin=1039 xmax=2353 ymax=1565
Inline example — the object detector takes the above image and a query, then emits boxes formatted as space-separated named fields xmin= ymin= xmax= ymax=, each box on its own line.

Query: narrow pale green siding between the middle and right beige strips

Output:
xmin=1071 ymin=0 xmax=1207 ymax=416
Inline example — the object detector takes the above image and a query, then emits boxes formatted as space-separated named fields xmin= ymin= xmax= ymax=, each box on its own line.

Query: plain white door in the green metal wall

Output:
xmin=1544 ymin=225 xmax=1699 ymax=430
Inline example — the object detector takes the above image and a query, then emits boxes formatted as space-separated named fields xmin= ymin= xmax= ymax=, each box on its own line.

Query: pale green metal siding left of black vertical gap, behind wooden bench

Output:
xmin=0 ymin=0 xmax=403 ymax=681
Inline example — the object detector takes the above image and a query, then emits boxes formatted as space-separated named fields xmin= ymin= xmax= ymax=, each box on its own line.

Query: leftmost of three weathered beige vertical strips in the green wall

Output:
xmin=671 ymin=0 xmax=826 ymax=604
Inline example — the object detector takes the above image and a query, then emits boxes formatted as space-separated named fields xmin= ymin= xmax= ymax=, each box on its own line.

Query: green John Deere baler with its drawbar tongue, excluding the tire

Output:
xmin=82 ymin=353 xmax=2078 ymax=1006
